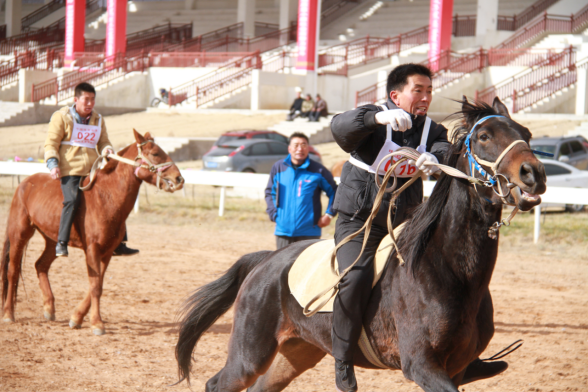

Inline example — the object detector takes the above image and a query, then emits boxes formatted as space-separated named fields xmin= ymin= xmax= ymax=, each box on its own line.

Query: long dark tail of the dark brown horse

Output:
xmin=176 ymin=251 xmax=271 ymax=384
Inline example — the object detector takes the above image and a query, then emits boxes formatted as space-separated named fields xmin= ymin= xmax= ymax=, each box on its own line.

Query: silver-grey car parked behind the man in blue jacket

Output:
xmin=202 ymin=139 xmax=320 ymax=173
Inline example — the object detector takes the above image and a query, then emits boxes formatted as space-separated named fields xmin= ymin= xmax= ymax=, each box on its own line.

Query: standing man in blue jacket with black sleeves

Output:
xmin=265 ymin=133 xmax=337 ymax=249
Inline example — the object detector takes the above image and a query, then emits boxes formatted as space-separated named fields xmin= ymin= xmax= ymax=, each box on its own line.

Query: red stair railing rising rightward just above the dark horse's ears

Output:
xmin=475 ymin=47 xmax=577 ymax=113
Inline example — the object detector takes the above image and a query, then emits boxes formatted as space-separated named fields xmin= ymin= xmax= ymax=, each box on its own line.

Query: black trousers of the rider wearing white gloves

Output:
xmin=331 ymin=213 xmax=388 ymax=361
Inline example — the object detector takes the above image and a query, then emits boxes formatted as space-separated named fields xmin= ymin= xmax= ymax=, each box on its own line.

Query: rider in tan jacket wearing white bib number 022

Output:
xmin=45 ymin=83 xmax=139 ymax=257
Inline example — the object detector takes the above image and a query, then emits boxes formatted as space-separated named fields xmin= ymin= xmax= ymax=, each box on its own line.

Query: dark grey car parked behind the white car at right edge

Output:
xmin=531 ymin=136 xmax=588 ymax=170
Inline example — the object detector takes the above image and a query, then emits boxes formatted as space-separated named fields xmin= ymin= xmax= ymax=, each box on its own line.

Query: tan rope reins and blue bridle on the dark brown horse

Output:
xmin=302 ymin=115 xmax=526 ymax=317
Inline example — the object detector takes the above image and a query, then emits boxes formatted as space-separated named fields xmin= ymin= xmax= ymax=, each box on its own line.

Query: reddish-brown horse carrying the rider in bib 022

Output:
xmin=0 ymin=131 xmax=184 ymax=335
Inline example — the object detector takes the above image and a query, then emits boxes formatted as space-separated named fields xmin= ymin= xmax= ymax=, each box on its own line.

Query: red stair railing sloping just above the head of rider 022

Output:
xmin=31 ymin=55 xmax=149 ymax=103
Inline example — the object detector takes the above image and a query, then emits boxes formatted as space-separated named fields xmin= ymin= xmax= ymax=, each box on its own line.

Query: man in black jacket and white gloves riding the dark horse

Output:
xmin=331 ymin=64 xmax=508 ymax=392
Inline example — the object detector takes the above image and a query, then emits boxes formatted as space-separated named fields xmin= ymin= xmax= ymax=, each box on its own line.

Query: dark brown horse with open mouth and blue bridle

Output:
xmin=176 ymin=99 xmax=546 ymax=392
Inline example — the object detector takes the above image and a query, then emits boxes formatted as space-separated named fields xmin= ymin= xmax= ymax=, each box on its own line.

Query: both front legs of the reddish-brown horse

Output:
xmin=69 ymin=244 xmax=111 ymax=335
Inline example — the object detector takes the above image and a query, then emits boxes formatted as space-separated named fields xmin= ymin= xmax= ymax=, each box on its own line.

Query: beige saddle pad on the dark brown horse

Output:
xmin=288 ymin=223 xmax=404 ymax=312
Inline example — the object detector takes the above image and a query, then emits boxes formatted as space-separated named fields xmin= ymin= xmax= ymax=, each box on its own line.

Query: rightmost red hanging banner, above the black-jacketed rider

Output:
xmin=429 ymin=0 xmax=453 ymax=71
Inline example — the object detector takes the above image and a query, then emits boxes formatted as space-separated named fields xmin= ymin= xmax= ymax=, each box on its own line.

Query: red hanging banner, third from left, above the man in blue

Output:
xmin=296 ymin=0 xmax=318 ymax=71
